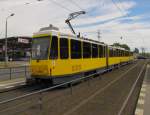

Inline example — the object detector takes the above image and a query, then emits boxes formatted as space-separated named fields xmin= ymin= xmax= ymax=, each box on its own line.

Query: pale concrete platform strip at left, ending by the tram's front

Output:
xmin=0 ymin=78 xmax=26 ymax=92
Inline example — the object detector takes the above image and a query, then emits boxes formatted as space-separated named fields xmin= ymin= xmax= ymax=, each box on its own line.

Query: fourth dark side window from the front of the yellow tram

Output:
xmin=83 ymin=42 xmax=91 ymax=58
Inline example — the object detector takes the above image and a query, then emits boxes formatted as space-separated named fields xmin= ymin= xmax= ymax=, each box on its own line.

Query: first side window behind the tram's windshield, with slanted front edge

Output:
xmin=50 ymin=36 xmax=58 ymax=59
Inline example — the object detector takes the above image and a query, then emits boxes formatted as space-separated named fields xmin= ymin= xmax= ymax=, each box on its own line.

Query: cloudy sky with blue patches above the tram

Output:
xmin=0 ymin=0 xmax=150 ymax=52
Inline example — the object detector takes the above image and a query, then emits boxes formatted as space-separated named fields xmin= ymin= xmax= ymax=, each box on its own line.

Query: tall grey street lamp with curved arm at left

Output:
xmin=5 ymin=13 xmax=15 ymax=66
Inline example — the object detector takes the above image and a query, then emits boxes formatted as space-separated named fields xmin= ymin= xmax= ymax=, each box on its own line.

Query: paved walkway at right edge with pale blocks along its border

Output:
xmin=135 ymin=65 xmax=150 ymax=115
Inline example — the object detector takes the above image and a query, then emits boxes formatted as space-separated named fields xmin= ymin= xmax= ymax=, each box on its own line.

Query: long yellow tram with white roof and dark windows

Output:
xmin=31 ymin=25 xmax=133 ymax=84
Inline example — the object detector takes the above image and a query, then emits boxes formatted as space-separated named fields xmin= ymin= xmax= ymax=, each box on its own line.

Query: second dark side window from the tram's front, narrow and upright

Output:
xmin=60 ymin=38 xmax=69 ymax=59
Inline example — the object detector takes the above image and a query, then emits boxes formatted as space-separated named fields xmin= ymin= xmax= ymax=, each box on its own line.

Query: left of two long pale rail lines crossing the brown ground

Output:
xmin=63 ymin=63 xmax=139 ymax=115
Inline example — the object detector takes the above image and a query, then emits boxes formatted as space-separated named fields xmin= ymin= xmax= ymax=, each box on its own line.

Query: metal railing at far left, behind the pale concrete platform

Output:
xmin=0 ymin=66 xmax=30 ymax=81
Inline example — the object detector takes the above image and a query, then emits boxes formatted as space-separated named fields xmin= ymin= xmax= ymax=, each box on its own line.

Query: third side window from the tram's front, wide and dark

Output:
xmin=71 ymin=40 xmax=81 ymax=59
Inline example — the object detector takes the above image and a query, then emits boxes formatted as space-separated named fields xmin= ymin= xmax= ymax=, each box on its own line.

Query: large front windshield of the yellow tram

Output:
xmin=32 ymin=37 xmax=50 ymax=60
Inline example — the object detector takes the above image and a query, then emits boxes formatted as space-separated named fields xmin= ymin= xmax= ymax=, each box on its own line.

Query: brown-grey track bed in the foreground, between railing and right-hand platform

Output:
xmin=0 ymin=59 xmax=144 ymax=115
